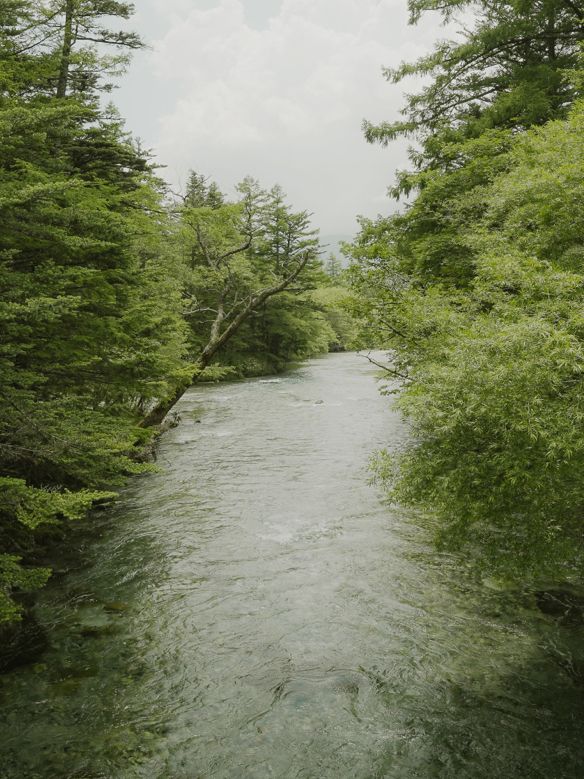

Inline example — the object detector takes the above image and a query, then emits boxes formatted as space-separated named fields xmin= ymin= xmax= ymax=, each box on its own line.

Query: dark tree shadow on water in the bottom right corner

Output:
xmin=374 ymin=648 xmax=584 ymax=779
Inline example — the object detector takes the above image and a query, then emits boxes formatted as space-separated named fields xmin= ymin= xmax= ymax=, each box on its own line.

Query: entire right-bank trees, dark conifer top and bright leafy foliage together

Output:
xmin=350 ymin=0 xmax=584 ymax=582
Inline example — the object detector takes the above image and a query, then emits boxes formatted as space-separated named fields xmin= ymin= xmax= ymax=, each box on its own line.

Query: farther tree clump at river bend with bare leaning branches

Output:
xmin=179 ymin=173 xmax=334 ymax=375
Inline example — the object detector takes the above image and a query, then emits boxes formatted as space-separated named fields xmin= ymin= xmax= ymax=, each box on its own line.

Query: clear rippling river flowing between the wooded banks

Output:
xmin=0 ymin=354 xmax=584 ymax=779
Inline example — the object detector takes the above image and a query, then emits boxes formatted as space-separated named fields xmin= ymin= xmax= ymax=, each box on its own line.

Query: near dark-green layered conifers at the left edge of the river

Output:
xmin=0 ymin=0 xmax=186 ymax=620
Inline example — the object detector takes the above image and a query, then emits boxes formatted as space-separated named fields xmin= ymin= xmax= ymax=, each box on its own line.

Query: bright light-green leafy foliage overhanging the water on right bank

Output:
xmin=368 ymin=99 xmax=584 ymax=578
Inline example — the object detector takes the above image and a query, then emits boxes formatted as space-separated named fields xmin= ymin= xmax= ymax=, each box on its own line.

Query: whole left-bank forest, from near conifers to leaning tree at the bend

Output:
xmin=0 ymin=0 xmax=356 ymax=623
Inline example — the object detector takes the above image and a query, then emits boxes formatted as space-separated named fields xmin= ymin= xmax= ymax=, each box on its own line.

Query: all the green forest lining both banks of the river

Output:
xmin=0 ymin=0 xmax=584 ymax=656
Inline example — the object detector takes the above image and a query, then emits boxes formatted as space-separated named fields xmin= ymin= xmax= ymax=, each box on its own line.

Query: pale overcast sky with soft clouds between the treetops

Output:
xmin=113 ymin=0 xmax=445 ymax=235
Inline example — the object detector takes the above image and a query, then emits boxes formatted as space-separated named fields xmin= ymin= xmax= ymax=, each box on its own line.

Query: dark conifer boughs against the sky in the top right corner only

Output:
xmin=365 ymin=0 xmax=583 ymax=147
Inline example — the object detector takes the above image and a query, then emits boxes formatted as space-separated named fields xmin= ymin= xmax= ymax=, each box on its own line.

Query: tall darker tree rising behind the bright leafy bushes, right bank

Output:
xmin=364 ymin=0 xmax=584 ymax=286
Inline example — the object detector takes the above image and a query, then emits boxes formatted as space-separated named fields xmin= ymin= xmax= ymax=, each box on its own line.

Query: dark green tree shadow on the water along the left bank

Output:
xmin=0 ymin=502 xmax=173 ymax=779
